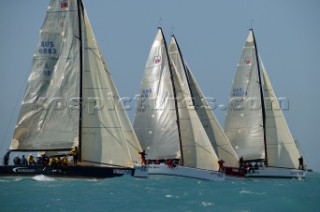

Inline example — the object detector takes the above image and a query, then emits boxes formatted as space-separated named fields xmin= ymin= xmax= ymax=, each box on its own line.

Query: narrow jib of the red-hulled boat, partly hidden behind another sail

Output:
xmin=186 ymin=65 xmax=239 ymax=167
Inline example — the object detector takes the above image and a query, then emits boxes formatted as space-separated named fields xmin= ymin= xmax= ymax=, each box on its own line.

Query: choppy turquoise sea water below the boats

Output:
xmin=0 ymin=173 xmax=320 ymax=212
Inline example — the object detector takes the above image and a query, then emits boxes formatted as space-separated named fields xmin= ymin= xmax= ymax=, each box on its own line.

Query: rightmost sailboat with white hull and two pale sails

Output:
xmin=224 ymin=29 xmax=306 ymax=178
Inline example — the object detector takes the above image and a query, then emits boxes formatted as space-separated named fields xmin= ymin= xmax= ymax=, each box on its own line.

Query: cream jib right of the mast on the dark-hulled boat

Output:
xmin=81 ymin=9 xmax=141 ymax=167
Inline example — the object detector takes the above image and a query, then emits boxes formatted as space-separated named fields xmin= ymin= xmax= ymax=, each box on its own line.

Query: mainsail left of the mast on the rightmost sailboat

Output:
xmin=224 ymin=31 xmax=265 ymax=160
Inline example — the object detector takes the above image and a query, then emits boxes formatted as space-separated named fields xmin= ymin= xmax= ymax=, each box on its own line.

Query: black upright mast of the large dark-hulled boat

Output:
xmin=77 ymin=0 xmax=84 ymax=161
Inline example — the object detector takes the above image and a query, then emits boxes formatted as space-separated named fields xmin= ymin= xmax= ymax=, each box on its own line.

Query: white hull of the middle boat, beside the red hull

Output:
xmin=149 ymin=163 xmax=225 ymax=181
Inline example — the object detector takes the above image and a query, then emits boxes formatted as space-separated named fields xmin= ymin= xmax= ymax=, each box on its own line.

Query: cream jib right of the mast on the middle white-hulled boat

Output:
xmin=169 ymin=53 xmax=219 ymax=170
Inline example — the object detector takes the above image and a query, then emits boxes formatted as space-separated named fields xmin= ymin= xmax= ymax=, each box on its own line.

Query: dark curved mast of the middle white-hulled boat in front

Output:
xmin=158 ymin=27 xmax=183 ymax=165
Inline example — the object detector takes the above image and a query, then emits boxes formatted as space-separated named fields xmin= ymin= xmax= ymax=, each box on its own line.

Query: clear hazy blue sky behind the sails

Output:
xmin=0 ymin=0 xmax=320 ymax=171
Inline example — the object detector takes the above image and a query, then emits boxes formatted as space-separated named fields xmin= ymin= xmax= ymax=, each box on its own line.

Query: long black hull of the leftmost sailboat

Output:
xmin=0 ymin=165 xmax=135 ymax=179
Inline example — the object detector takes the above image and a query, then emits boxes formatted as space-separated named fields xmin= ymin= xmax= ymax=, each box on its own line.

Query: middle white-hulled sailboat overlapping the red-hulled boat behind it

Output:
xmin=133 ymin=28 xmax=225 ymax=181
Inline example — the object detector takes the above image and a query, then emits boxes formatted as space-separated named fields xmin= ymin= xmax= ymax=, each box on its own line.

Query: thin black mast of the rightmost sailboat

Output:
xmin=249 ymin=28 xmax=268 ymax=166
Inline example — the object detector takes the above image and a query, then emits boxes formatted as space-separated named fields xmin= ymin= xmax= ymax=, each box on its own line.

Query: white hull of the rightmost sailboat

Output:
xmin=246 ymin=167 xmax=306 ymax=178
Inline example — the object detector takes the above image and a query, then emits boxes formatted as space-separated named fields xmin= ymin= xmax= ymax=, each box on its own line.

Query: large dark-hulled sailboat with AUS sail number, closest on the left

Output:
xmin=0 ymin=0 xmax=148 ymax=178
